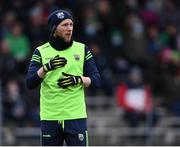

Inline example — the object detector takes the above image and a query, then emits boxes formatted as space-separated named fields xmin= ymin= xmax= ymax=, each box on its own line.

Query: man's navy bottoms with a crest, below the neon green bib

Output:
xmin=41 ymin=118 xmax=88 ymax=146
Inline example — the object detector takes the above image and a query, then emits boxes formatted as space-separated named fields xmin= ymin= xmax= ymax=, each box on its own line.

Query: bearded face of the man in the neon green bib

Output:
xmin=54 ymin=19 xmax=73 ymax=42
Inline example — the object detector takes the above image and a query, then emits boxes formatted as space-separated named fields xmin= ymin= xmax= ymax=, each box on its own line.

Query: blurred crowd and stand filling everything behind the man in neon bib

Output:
xmin=0 ymin=0 xmax=180 ymax=146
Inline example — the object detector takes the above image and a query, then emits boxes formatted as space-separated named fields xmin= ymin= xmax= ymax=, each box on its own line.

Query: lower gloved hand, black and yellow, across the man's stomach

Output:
xmin=57 ymin=72 xmax=82 ymax=88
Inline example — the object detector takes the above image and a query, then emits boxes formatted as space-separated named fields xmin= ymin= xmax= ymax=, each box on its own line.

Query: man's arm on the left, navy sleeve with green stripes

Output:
xmin=26 ymin=49 xmax=45 ymax=89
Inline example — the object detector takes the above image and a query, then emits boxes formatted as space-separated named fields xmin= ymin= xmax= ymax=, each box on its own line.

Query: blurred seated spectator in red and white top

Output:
xmin=116 ymin=67 xmax=156 ymax=127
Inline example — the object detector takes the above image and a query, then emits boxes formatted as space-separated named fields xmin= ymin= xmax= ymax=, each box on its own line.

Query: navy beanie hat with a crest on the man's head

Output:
xmin=48 ymin=10 xmax=73 ymax=32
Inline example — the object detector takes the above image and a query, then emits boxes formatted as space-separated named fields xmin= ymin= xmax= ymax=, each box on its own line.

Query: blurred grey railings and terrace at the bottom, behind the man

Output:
xmin=1 ymin=97 xmax=180 ymax=146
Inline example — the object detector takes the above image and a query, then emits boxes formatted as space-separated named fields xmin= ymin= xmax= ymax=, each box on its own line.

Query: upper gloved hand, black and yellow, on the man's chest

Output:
xmin=43 ymin=55 xmax=67 ymax=72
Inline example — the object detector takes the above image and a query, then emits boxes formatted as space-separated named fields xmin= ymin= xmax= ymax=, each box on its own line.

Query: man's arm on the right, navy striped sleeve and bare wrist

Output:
xmin=81 ymin=46 xmax=101 ymax=87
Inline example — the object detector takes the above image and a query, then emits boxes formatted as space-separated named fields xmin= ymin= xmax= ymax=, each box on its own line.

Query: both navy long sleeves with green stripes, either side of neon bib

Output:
xmin=26 ymin=46 xmax=100 ymax=89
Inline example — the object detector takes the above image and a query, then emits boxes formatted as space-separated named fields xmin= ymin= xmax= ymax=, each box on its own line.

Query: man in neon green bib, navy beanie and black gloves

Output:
xmin=26 ymin=10 xmax=100 ymax=146
